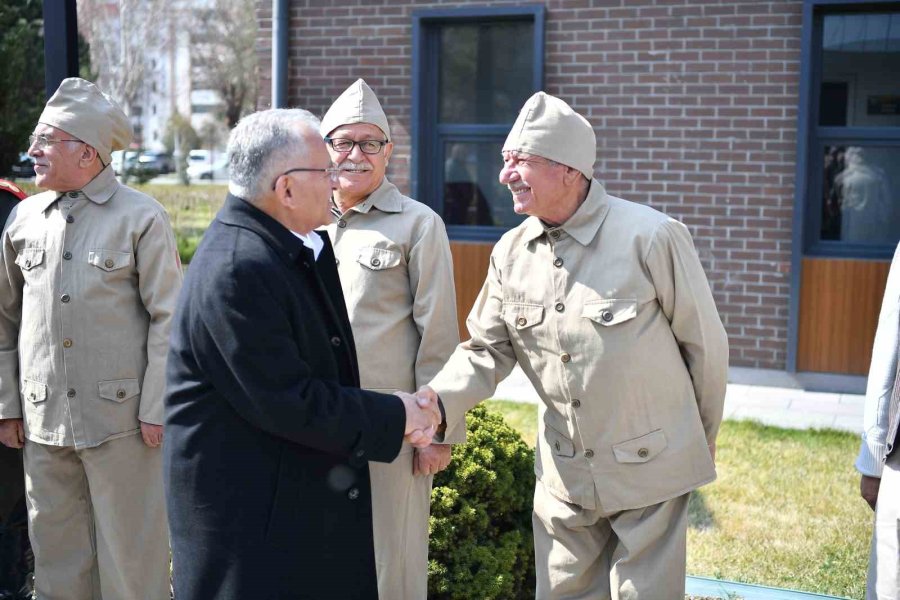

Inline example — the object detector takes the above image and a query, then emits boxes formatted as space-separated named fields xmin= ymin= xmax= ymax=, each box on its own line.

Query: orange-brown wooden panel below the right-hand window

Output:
xmin=797 ymin=258 xmax=890 ymax=375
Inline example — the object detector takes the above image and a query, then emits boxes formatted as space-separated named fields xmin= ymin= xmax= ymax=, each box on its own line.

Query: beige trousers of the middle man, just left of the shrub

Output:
xmin=369 ymin=443 xmax=434 ymax=600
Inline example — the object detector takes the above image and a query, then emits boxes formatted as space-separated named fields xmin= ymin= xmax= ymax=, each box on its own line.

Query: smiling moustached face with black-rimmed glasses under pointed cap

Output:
xmin=328 ymin=123 xmax=394 ymax=210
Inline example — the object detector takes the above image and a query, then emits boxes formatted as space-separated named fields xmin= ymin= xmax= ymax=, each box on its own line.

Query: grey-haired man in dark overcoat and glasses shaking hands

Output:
xmin=164 ymin=110 xmax=440 ymax=600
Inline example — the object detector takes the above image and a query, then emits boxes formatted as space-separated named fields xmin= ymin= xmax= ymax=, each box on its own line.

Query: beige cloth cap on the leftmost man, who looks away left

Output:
xmin=38 ymin=77 xmax=134 ymax=165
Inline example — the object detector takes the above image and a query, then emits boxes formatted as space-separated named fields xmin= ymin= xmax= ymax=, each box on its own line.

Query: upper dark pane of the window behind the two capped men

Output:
xmin=438 ymin=21 xmax=534 ymax=123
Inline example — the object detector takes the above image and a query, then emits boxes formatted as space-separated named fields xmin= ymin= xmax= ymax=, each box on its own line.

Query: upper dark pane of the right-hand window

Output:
xmin=819 ymin=12 xmax=900 ymax=127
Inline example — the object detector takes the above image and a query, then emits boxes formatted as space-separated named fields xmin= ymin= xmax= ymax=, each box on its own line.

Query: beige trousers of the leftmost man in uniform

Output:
xmin=25 ymin=435 xmax=169 ymax=600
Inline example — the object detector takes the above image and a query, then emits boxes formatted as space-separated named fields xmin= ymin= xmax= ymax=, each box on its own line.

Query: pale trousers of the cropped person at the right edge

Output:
xmin=866 ymin=452 xmax=900 ymax=600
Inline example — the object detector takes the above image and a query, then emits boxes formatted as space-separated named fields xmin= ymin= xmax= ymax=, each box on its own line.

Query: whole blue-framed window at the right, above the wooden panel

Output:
xmin=794 ymin=0 xmax=900 ymax=258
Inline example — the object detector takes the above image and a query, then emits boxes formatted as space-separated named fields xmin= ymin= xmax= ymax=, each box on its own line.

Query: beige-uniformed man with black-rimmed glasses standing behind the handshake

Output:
xmin=319 ymin=79 xmax=465 ymax=600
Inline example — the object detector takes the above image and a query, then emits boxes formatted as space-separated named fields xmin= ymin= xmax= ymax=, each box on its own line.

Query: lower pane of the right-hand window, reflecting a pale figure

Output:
xmin=821 ymin=146 xmax=900 ymax=244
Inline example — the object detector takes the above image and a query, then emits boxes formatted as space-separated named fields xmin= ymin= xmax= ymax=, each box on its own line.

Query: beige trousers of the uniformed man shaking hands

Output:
xmin=532 ymin=481 xmax=690 ymax=600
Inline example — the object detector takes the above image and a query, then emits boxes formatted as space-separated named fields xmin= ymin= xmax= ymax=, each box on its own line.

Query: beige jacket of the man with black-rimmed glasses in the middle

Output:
xmin=327 ymin=179 xmax=459 ymax=414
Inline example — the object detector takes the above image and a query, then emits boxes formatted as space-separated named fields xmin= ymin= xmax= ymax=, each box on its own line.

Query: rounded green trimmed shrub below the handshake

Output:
xmin=428 ymin=406 xmax=535 ymax=600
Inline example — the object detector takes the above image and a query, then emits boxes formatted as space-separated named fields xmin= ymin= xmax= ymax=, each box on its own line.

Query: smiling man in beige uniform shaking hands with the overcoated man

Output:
xmin=420 ymin=92 xmax=728 ymax=600
